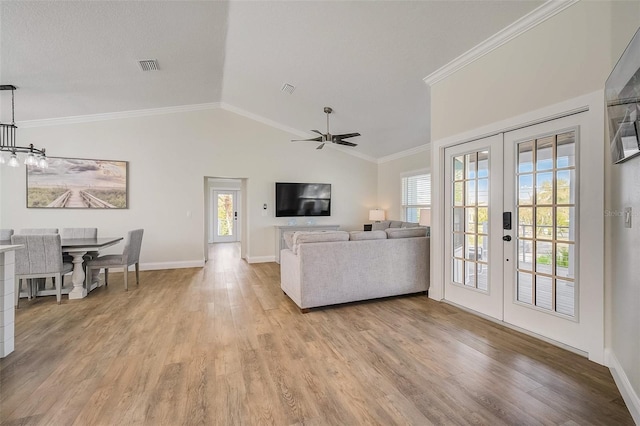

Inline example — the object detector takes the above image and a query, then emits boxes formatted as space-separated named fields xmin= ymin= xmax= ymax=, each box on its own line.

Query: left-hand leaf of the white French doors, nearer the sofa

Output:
xmin=445 ymin=135 xmax=503 ymax=320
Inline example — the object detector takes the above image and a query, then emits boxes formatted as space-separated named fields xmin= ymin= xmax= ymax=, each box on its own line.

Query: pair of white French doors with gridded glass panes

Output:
xmin=444 ymin=114 xmax=603 ymax=353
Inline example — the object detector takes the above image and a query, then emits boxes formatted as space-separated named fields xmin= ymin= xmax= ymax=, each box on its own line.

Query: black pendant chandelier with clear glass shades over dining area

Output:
xmin=0 ymin=84 xmax=48 ymax=169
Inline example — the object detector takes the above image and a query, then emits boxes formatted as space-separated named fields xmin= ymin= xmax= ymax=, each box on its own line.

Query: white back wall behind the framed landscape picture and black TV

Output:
xmin=0 ymin=109 xmax=377 ymax=268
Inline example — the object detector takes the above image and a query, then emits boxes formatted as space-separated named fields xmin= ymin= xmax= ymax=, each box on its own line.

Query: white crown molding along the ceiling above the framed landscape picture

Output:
xmin=17 ymin=102 xmax=220 ymax=128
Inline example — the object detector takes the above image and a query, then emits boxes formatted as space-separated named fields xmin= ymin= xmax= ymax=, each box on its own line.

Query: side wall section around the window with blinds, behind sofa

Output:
xmin=373 ymin=146 xmax=431 ymax=220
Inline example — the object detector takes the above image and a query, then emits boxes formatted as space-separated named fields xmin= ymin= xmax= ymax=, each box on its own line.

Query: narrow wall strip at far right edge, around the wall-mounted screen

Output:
xmin=605 ymin=1 xmax=640 ymax=424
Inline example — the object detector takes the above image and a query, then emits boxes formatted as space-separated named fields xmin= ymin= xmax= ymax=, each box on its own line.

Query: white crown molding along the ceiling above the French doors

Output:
xmin=423 ymin=0 xmax=579 ymax=86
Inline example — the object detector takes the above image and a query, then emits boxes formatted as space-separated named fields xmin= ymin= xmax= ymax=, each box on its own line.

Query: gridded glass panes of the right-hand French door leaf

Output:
xmin=515 ymin=132 xmax=577 ymax=317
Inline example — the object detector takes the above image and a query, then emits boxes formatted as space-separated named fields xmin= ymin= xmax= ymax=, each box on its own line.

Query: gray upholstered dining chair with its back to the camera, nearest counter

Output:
xmin=11 ymin=234 xmax=73 ymax=308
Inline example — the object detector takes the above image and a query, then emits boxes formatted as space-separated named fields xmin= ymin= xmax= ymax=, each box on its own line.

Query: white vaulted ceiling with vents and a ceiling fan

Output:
xmin=0 ymin=0 xmax=543 ymax=158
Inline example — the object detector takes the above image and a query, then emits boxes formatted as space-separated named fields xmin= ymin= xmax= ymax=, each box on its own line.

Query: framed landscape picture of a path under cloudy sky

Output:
xmin=27 ymin=157 xmax=129 ymax=209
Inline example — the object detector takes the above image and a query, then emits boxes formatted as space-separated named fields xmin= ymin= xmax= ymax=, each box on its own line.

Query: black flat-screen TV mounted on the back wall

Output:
xmin=276 ymin=182 xmax=331 ymax=217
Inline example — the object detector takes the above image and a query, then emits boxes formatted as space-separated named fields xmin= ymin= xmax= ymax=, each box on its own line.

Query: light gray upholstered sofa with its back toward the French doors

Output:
xmin=280 ymin=227 xmax=429 ymax=312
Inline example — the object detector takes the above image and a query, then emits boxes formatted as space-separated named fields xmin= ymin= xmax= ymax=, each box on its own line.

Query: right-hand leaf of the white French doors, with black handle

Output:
xmin=504 ymin=113 xmax=603 ymax=353
